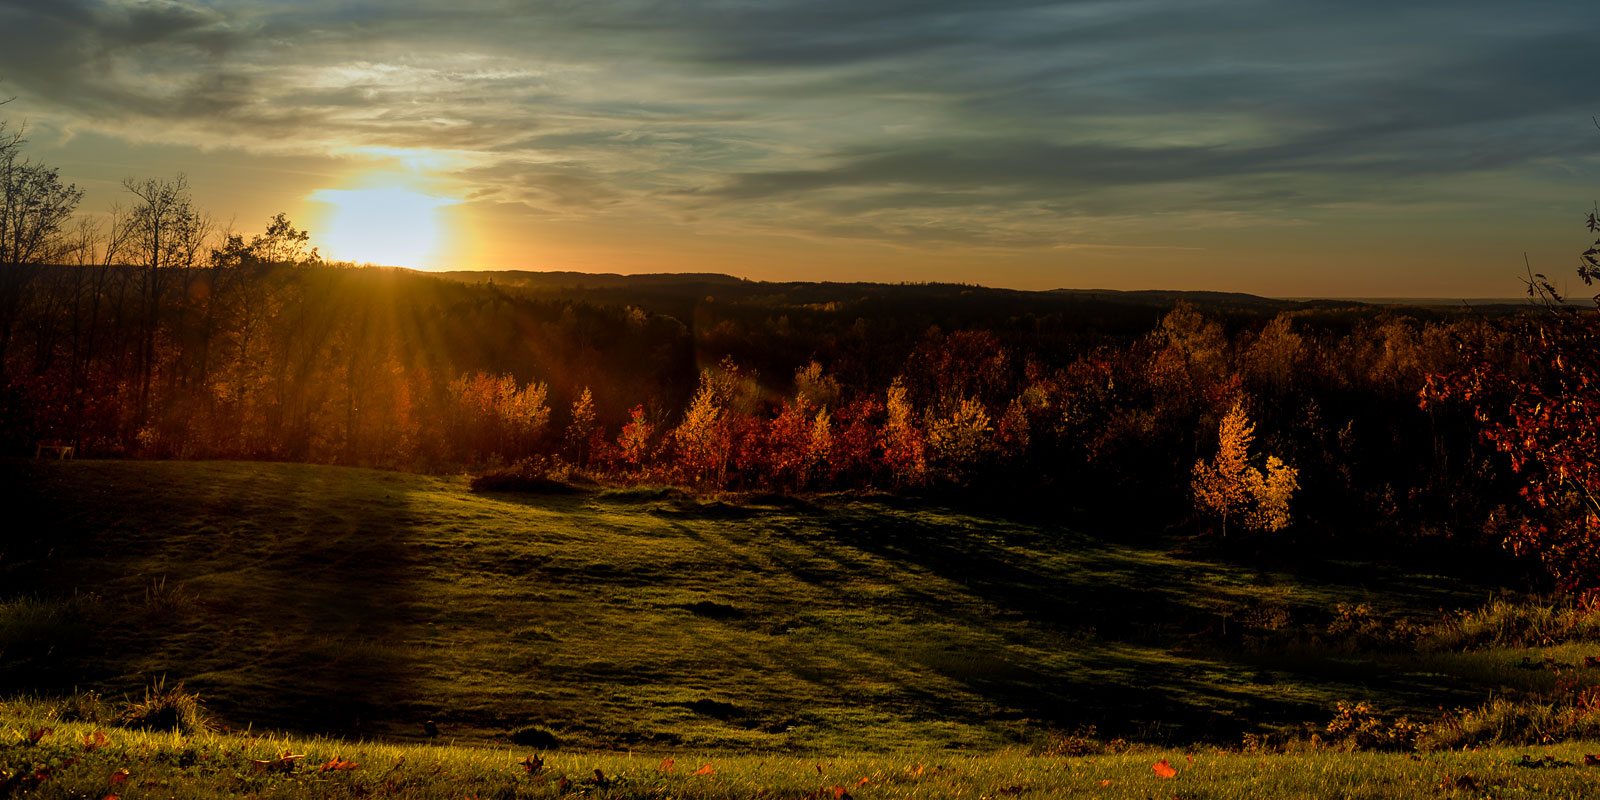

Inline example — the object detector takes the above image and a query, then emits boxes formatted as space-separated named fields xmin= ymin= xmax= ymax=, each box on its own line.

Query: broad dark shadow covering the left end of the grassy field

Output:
xmin=0 ymin=461 xmax=421 ymax=734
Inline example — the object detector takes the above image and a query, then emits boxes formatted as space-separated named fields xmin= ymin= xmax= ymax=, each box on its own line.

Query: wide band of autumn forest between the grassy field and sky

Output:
xmin=0 ymin=116 xmax=1600 ymax=592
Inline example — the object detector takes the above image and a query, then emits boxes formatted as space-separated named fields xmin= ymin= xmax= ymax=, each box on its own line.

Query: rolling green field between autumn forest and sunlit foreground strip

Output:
xmin=0 ymin=461 xmax=1600 ymax=752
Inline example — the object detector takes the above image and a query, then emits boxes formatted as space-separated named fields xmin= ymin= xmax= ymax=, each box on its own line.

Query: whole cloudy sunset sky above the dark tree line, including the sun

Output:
xmin=0 ymin=0 xmax=1600 ymax=298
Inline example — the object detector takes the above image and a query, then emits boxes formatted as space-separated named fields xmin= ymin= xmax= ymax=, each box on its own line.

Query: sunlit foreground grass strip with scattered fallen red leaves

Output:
xmin=0 ymin=702 xmax=1600 ymax=800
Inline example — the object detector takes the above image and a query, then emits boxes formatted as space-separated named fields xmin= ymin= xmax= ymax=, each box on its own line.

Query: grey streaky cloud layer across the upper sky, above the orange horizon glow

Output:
xmin=0 ymin=0 xmax=1600 ymax=246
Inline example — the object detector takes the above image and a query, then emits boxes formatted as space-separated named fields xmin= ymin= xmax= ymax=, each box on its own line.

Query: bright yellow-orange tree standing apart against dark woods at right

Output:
xmin=1190 ymin=403 xmax=1299 ymax=536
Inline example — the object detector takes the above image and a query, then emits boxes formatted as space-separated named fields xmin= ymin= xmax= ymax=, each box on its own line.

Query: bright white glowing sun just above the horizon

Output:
xmin=309 ymin=187 xmax=459 ymax=269
